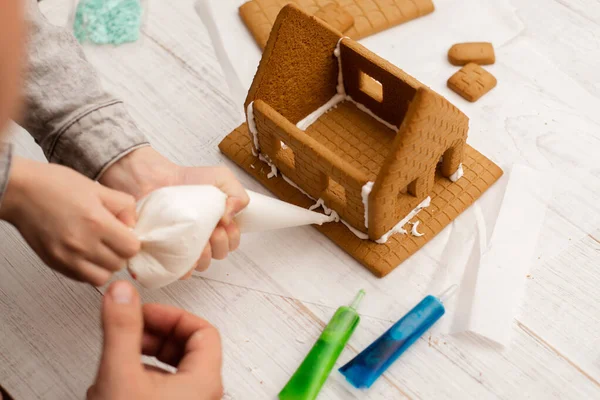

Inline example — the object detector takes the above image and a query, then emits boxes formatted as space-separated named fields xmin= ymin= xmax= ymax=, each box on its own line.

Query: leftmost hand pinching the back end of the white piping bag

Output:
xmin=0 ymin=158 xmax=140 ymax=286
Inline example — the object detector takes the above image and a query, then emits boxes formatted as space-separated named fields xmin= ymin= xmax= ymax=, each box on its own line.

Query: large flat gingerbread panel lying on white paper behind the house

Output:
xmin=240 ymin=0 xmax=435 ymax=49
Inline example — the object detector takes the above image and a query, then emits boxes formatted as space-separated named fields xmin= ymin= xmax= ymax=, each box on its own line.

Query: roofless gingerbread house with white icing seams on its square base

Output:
xmin=220 ymin=5 xmax=502 ymax=276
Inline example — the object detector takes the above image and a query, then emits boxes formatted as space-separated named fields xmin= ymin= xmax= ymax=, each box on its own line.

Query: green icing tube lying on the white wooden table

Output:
xmin=279 ymin=290 xmax=365 ymax=400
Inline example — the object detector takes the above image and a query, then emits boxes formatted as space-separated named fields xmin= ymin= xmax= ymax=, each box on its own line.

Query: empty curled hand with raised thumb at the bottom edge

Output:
xmin=87 ymin=281 xmax=223 ymax=400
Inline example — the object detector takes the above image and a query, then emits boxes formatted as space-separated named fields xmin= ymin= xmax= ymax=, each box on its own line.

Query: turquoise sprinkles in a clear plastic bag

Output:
xmin=73 ymin=0 xmax=143 ymax=45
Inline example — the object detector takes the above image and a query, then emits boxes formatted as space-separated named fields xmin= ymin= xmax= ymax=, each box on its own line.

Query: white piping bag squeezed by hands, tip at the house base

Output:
xmin=127 ymin=185 xmax=335 ymax=289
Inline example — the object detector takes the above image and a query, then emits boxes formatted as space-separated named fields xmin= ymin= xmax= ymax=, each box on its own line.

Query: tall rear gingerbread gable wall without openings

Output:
xmin=245 ymin=6 xmax=341 ymax=124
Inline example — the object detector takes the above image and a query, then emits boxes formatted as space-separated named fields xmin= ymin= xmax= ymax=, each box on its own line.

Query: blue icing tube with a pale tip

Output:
xmin=340 ymin=285 xmax=458 ymax=389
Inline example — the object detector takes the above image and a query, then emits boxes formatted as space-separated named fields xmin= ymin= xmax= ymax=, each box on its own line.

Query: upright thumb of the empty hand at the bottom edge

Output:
xmin=98 ymin=281 xmax=144 ymax=380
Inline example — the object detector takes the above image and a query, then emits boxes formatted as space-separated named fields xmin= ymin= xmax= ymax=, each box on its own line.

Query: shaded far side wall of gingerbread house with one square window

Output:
xmin=340 ymin=40 xmax=423 ymax=127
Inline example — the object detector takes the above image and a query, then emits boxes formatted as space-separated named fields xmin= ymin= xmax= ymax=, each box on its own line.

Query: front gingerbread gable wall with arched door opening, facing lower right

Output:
xmin=369 ymin=87 xmax=469 ymax=239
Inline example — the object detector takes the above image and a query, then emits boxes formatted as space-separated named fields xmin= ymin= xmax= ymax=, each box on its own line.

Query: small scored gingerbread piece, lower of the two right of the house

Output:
xmin=448 ymin=63 xmax=497 ymax=102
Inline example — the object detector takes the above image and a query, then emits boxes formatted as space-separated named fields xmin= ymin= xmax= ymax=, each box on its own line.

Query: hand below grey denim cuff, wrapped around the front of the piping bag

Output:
xmin=100 ymin=147 xmax=250 ymax=279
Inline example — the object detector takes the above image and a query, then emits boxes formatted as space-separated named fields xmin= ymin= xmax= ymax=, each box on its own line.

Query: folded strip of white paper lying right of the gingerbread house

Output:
xmin=469 ymin=165 xmax=551 ymax=346
